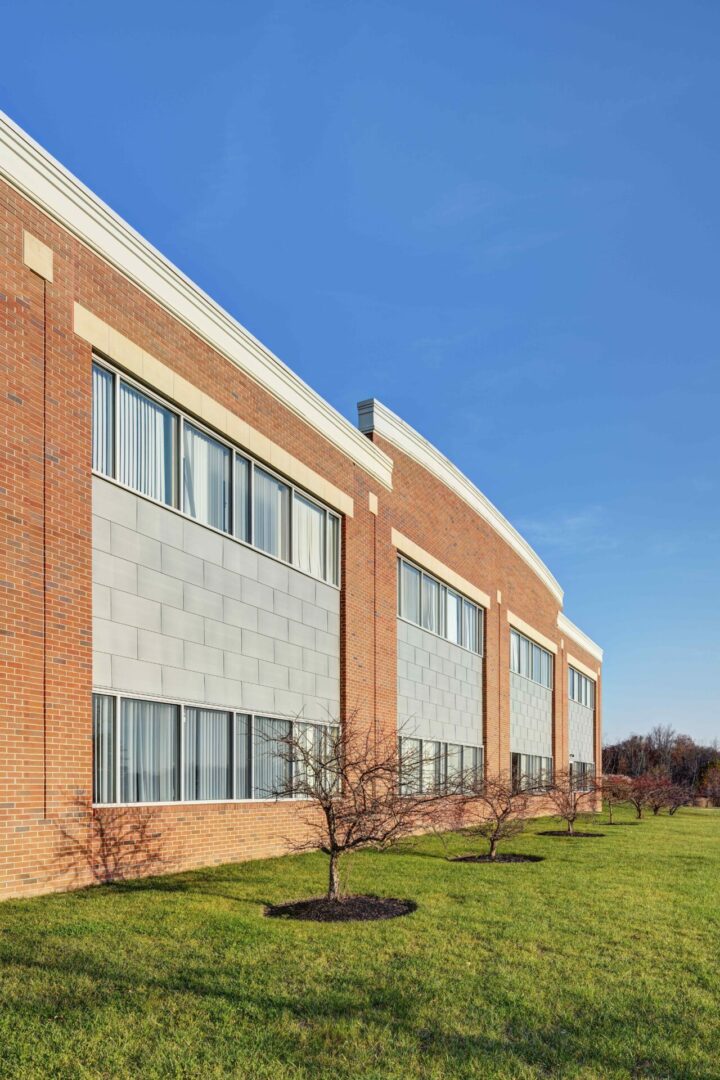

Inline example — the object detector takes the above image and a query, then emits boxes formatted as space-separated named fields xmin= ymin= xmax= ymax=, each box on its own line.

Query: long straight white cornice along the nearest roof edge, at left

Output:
xmin=0 ymin=111 xmax=392 ymax=488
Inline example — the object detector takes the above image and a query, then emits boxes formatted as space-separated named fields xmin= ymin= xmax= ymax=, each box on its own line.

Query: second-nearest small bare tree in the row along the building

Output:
xmin=453 ymin=773 xmax=531 ymax=860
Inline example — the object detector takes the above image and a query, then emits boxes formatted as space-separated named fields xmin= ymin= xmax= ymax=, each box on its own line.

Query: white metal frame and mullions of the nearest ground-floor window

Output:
xmin=91 ymin=687 xmax=341 ymax=810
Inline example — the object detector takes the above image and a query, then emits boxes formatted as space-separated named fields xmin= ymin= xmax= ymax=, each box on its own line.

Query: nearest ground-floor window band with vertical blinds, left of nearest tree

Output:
xmin=93 ymin=693 xmax=338 ymax=804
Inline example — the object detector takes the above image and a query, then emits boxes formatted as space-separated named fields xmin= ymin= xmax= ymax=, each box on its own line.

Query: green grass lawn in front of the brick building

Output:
xmin=0 ymin=810 xmax=720 ymax=1080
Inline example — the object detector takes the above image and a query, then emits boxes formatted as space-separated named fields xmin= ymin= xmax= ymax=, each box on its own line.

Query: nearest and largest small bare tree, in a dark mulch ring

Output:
xmin=273 ymin=718 xmax=447 ymax=901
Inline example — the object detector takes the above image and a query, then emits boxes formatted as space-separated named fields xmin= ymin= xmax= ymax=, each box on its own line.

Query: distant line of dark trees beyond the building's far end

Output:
xmin=602 ymin=725 xmax=720 ymax=792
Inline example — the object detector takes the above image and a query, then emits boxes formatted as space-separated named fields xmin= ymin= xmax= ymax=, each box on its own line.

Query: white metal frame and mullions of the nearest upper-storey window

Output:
xmin=91 ymin=350 xmax=343 ymax=590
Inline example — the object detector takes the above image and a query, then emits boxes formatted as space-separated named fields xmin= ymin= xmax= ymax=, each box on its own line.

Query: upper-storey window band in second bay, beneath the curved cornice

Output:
xmin=397 ymin=558 xmax=483 ymax=653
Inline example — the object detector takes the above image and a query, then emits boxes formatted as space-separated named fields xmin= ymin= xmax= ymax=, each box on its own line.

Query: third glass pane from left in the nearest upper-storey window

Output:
xmin=182 ymin=422 xmax=232 ymax=532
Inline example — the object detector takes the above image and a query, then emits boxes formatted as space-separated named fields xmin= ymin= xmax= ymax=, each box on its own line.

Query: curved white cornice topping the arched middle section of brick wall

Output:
xmin=357 ymin=399 xmax=562 ymax=605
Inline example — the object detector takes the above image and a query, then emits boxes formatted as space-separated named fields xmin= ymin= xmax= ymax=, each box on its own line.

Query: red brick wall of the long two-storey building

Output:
xmin=0 ymin=183 xmax=599 ymax=896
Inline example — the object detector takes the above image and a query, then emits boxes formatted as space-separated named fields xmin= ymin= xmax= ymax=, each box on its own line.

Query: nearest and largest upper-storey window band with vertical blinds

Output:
xmin=93 ymin=363 xmax=340 ymax=585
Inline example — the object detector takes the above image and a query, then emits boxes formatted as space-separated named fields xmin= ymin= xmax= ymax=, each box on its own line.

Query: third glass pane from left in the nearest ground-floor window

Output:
xmin=185 ymin=708 xmax=232 ymax=800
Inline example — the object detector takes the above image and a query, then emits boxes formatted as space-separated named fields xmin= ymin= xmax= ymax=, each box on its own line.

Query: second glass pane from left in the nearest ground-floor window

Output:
xmin=120 ymin=698 xmax=180 ymax=802
